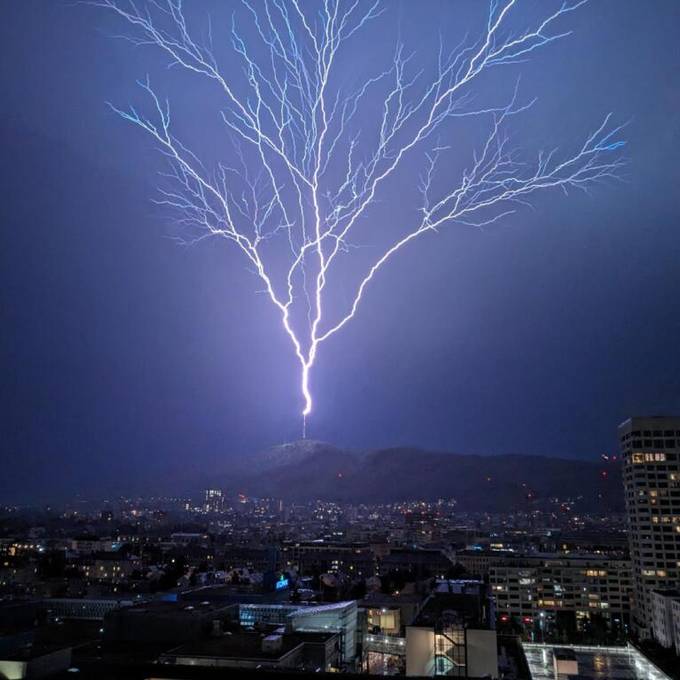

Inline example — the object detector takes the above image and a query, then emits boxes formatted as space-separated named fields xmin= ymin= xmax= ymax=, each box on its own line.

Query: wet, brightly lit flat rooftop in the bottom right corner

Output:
xmin=522 ymin=643 xmax=671 ymax=680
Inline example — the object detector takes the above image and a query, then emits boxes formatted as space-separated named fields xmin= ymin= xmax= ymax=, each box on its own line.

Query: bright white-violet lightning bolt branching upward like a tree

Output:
xmin=93 ymin=0 xmax=624 ymax=436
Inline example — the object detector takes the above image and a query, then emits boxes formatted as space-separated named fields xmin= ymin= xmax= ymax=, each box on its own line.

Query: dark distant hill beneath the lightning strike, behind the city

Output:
xmin=211 ymin=440 xmax=623 ymax=512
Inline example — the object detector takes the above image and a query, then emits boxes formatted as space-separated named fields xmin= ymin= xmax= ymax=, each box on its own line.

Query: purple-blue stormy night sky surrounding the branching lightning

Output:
xmin=0 ymin=0 xmax=680 ymax=502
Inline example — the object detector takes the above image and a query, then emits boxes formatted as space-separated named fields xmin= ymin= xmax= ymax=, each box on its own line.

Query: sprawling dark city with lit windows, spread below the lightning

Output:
xmin=0 ymin=417 xmax=680 ymax=680
